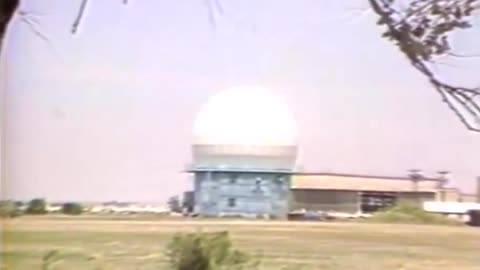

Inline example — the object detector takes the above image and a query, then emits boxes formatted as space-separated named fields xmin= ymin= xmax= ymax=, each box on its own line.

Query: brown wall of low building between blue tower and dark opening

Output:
xmin=290 ymin=189 xmax=359 ymax=213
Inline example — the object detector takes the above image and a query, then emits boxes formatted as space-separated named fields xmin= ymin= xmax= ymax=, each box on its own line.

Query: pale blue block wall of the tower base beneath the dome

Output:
xmin=195 ymin=172 xmax=289 ymax=217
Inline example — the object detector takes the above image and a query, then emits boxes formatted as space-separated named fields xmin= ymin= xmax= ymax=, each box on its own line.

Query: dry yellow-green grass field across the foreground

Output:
xmin=2 ymin=217 xmax=480 ymax=270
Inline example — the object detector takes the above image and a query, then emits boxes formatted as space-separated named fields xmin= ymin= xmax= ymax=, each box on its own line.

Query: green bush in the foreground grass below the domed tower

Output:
xmin=167 ymin=232 xmax=258 ymax=270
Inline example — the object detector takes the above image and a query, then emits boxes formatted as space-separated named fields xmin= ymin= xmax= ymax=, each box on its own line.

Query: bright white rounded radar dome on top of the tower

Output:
xmin=193 ymin=86 xmax=297 ymax=146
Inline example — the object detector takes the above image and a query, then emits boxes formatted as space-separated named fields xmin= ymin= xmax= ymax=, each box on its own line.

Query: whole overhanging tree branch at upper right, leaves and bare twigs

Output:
xmin=369 ymin=0 xmax=480 ymax=132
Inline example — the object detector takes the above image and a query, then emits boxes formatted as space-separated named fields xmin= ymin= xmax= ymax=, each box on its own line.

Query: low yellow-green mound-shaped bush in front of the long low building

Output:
xmin=369 ymin=203 xmax=463 ymax=225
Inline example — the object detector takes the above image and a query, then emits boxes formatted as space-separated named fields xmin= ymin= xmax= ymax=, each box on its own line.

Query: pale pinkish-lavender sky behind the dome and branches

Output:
xmin=1 ymin=0 xmax=480 ymax=201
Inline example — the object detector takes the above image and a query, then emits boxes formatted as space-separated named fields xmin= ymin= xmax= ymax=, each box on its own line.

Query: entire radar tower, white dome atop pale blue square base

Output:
xmin=189 ymin=87 xmax=297 ymax=217
